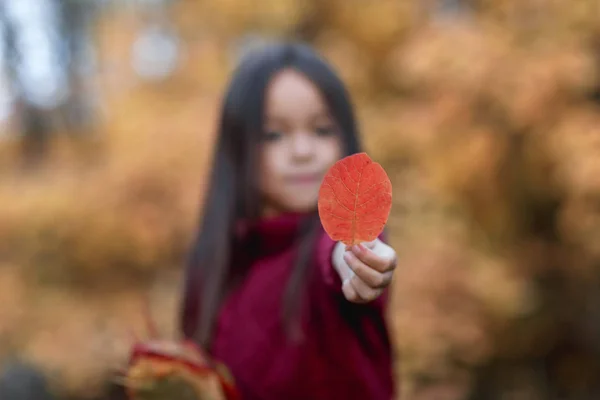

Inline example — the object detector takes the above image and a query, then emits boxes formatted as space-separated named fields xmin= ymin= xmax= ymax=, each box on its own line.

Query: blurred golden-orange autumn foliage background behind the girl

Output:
xmin=0 ymin=0 xmax=600 ymax=400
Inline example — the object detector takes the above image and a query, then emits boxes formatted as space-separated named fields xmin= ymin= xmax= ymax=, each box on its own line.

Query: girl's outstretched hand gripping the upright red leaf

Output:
xmin=333 ymin=239 xmax=397 ymax=303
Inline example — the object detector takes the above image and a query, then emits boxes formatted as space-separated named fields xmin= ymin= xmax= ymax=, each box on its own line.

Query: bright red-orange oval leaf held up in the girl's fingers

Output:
xmin=318 ymin=153 xmax=392 ymax=246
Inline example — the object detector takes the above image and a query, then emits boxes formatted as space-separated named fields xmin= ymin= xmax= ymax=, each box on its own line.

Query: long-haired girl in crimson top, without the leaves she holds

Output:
xmin=182 ymin=43 xmax=396 ymax=400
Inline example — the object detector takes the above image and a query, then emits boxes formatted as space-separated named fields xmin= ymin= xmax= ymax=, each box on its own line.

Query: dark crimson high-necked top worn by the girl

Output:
xmin=184 ymin=214 xmax=394 ymax=400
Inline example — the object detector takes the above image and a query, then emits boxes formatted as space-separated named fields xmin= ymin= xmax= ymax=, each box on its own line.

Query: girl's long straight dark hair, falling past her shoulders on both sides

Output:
xmin=181 ymin=42 xmax=361 ymax=348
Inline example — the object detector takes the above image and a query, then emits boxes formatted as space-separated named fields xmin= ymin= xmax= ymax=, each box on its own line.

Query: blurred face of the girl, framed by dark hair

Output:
xmin=260 ymin=70 xmax=343 ymax=216
